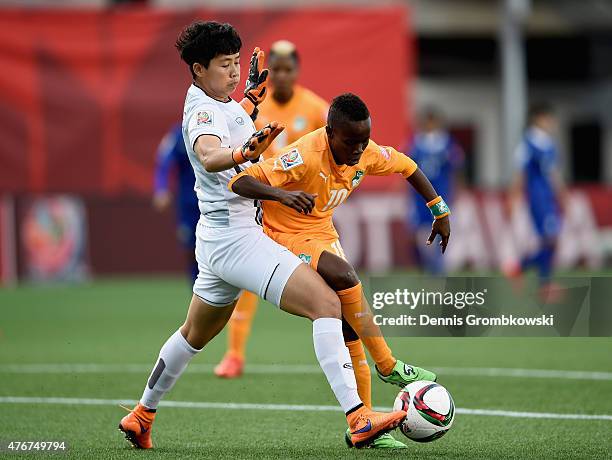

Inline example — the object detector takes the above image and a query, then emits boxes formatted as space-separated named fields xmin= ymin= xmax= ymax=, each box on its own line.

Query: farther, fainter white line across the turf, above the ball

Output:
xmin=0 ymin=363 xmax=612 ymax=381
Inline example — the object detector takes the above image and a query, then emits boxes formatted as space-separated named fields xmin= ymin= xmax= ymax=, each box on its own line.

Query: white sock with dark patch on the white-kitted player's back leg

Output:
xmin=140 ymin=330 xmax=200 ymax=409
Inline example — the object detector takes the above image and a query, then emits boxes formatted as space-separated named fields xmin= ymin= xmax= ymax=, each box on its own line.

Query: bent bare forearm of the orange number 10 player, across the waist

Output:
xmin=230 ymin=172 xmax=317 ymax=214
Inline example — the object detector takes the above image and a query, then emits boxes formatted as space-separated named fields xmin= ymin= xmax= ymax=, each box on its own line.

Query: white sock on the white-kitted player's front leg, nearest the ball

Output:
xmin=312 ymin=318 xmax=361 ymax=413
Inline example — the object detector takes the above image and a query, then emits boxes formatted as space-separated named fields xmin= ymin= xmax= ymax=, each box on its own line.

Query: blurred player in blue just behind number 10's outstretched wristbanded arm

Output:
xmin=406 ymin=107 xmax=464 ymax=275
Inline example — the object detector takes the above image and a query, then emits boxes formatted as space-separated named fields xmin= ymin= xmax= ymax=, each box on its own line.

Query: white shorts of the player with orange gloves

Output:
xmin=193 ymin=223 xmax=302 ymax=307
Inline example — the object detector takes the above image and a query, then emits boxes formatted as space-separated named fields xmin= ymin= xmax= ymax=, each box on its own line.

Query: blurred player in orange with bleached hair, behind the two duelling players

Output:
xmin=215 ymin=40 xmax=329 ymax=378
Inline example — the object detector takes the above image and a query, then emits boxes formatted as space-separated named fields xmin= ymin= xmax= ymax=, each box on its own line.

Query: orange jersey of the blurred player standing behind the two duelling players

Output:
xmin=255 ymin=85 xmax=329 ymax=158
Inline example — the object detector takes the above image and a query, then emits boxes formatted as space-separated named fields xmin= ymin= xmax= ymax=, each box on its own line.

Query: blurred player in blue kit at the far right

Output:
xmin=507 ymin=104 xmax=567 ymax=298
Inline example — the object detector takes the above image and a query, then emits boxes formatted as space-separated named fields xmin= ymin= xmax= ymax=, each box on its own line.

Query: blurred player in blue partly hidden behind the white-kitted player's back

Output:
xmin=153 ymin=123 xmax=200 ymax=285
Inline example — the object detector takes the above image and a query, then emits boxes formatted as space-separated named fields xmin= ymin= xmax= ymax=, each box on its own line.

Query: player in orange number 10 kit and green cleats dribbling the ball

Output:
xmin=228 ymin=93 xmax=450 ymax=447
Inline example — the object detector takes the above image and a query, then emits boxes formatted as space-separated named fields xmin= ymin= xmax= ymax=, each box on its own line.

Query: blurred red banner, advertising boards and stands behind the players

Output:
xmin=0 ymin=0 xmax=612 ymax=283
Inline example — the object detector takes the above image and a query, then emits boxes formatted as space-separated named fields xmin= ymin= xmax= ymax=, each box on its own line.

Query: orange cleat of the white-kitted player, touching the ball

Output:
xmin=346 ymin=406 xmax=406 ymax=448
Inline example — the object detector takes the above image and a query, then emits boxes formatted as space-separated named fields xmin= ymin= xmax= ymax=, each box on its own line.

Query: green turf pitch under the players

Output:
xmin=0 ymin=279 xmax=612 ymax=459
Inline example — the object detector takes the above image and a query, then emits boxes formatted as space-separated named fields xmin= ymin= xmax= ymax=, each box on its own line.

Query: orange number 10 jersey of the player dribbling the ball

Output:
xmin=228 ymin=128 xmax=417 ymax=240
